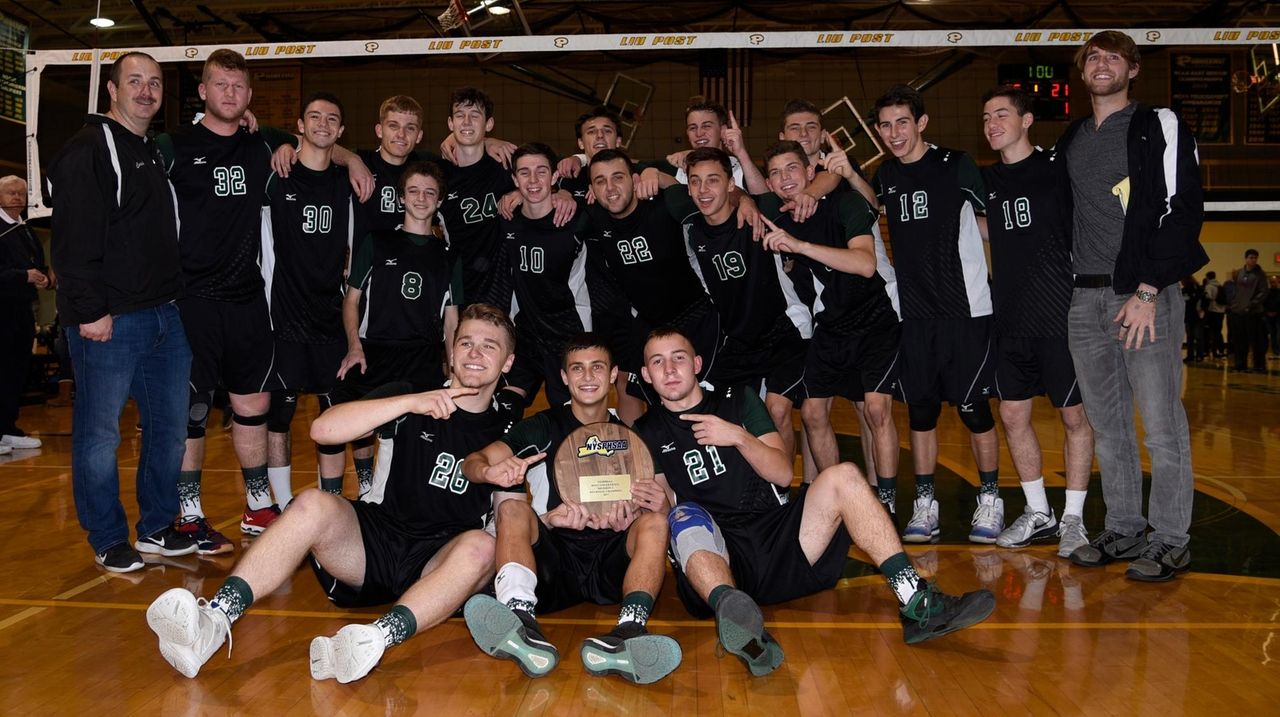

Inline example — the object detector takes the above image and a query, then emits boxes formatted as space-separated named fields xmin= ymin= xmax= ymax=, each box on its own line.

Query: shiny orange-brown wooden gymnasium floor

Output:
xmin=0 ymin=361 xmax=1280 ymax=717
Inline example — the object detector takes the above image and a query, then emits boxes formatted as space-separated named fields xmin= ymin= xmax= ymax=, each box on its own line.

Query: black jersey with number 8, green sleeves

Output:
xmin=347 ymin=229 xmax=453 ymax=343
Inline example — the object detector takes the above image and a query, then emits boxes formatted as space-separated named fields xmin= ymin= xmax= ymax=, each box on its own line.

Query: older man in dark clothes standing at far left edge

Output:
xmin=0 ymin=174 xmax=49 ymax=455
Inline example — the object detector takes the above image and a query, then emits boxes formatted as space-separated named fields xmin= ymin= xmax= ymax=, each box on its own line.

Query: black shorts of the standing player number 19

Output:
xmin=703 ymin=316 xmax=809 ymax=403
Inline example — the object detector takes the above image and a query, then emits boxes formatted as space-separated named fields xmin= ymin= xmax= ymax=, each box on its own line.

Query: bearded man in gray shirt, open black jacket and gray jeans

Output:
xmin=1057 ymin=31 xmax=1208 ymax=581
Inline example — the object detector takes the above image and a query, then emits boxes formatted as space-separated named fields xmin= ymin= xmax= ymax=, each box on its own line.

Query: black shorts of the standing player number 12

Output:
xmin=897 ymin=316 xmax=996 ymax=406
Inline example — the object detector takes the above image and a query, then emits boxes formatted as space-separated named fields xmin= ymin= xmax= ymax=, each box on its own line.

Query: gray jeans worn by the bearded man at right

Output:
xmin=1068 ymin=284 xmax=1196 ymax=545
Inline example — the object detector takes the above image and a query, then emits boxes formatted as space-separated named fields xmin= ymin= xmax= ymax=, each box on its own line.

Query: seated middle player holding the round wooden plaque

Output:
xmin=463 ymin=334 xmax=681 ymax=684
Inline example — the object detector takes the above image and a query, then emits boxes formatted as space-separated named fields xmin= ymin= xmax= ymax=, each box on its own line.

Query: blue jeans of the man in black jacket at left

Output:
xmin=65 ymin=303 xmax=191 ymax=553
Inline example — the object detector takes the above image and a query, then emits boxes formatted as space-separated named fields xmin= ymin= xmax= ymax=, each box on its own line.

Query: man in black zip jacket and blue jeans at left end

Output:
xmin=49 ymin=52 xmax=196 ymax=572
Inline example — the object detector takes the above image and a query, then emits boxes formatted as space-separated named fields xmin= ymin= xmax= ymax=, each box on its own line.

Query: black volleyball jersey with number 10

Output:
xmin=498 ymin=210 xmax=591 ymax=339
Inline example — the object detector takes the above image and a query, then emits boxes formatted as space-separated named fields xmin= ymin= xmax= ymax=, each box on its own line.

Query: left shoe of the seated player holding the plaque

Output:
xmin=462 ymin=595 xmax=559 ymax=677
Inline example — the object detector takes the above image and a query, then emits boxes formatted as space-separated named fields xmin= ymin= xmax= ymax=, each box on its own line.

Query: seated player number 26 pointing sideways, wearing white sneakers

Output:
xmin=147 ymin=303 xmax=515 ymax=682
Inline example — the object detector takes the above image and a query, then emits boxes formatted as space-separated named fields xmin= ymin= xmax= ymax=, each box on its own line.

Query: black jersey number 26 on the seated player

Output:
xmin=383 ymin=403 xmax=511 ymax=538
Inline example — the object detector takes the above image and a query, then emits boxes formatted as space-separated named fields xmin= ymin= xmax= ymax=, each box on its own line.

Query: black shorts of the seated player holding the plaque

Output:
xmin=534 ymin=520 xmax=631 ymax=612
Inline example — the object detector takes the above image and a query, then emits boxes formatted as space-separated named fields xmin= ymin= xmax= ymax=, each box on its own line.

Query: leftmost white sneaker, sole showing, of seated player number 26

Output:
xmin=147 ymin=588 xmax=232 ymax=677
